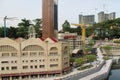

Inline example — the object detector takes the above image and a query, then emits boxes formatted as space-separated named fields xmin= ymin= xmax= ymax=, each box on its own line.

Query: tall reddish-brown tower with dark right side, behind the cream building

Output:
xmin=42 ymin=0 xmax=58 ymax=38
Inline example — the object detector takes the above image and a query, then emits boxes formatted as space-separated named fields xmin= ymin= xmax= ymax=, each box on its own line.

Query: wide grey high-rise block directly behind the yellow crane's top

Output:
xmin=79 ymin=15 xmax=95 ymax=25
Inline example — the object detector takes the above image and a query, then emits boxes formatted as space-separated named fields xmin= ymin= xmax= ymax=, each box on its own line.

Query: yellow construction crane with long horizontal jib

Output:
xmin=71 ymin=22 xmax=90 ymax=44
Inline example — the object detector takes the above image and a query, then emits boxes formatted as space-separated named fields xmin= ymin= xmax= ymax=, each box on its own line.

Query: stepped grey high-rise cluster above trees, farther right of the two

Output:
xmin=98 ymin=11 xmax=116 ymax=22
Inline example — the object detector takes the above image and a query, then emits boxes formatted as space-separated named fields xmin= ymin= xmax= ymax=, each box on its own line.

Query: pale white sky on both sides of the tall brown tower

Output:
xmin=0 ymin=0 xmax=120 ymax=29
